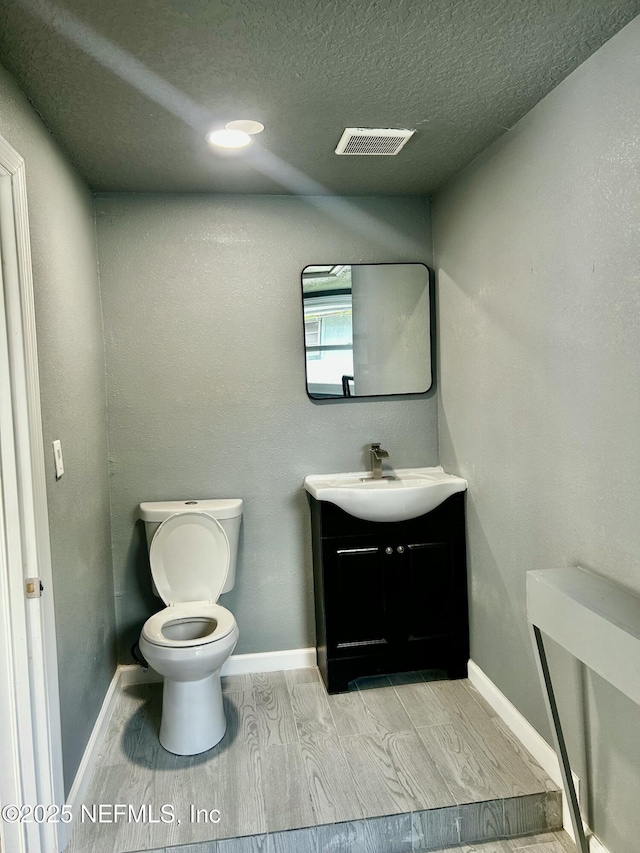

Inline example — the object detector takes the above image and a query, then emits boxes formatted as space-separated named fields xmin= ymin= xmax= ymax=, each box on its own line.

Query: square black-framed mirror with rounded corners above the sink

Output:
xmin=302 ymin=263 xmax=432 ymax=400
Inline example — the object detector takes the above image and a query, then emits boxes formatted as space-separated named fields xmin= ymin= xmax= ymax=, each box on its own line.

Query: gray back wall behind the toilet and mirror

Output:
xmin=96 ymin=195 xmax=438 ymax=660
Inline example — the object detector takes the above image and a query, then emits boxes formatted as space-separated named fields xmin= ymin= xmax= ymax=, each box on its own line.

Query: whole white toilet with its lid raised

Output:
xmin=140 ymin=499 xmax=242 ymax=755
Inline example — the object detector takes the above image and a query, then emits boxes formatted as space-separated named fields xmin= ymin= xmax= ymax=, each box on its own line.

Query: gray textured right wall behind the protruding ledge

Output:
xmin=433 ymin=19 xmax=640 ymax=853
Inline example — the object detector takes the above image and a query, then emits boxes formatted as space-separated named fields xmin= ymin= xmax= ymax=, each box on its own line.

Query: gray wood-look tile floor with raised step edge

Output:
xmin=68 ymin=668 xmax=575 ymax=853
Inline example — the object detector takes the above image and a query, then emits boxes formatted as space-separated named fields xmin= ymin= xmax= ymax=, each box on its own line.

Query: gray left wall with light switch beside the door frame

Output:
xmin=0 ymin=63 xmax=116 ymax=791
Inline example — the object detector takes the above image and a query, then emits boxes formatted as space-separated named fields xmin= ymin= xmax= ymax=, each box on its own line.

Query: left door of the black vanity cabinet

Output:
xmin=324 ymin=537 xmax=389 ymax=655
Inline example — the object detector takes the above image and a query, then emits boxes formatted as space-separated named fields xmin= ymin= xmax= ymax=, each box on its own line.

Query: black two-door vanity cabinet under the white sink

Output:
xmin=308 ymin=493 xmax=469 ymax=693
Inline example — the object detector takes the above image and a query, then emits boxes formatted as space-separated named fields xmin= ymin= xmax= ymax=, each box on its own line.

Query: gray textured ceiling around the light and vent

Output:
xmin=0 ymin=0 xmax=640 ymax=194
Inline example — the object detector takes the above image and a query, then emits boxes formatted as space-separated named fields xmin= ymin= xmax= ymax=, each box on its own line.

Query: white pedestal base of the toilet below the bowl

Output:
xmin=160 ymin=670 xmax=227 ymax=755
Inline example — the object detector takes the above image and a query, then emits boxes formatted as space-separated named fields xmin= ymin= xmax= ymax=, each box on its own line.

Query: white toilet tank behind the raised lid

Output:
xmin=140 ymin=498 xmax=243 ymax=595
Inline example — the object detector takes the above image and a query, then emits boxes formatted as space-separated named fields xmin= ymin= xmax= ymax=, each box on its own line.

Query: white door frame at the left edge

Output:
xmin=0 ymin=130 xmax=67 ymax=853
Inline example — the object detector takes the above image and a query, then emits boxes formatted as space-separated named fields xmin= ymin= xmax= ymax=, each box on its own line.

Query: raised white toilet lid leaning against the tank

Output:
xmin=149 ymin=512 xmax=229 ymax=604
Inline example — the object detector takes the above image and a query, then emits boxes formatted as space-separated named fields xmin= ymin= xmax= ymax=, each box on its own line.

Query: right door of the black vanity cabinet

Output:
xmin=405 ymin=542 xmax=457 ymax=642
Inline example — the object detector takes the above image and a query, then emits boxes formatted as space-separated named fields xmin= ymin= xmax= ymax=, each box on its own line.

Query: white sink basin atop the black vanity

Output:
xmin=304 ymin=467 xmax=467 ymax=521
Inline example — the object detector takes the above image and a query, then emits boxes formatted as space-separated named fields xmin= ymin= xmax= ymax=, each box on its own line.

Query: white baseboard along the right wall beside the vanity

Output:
xmin=468 ymin=660 xmax=609 ymax=853
